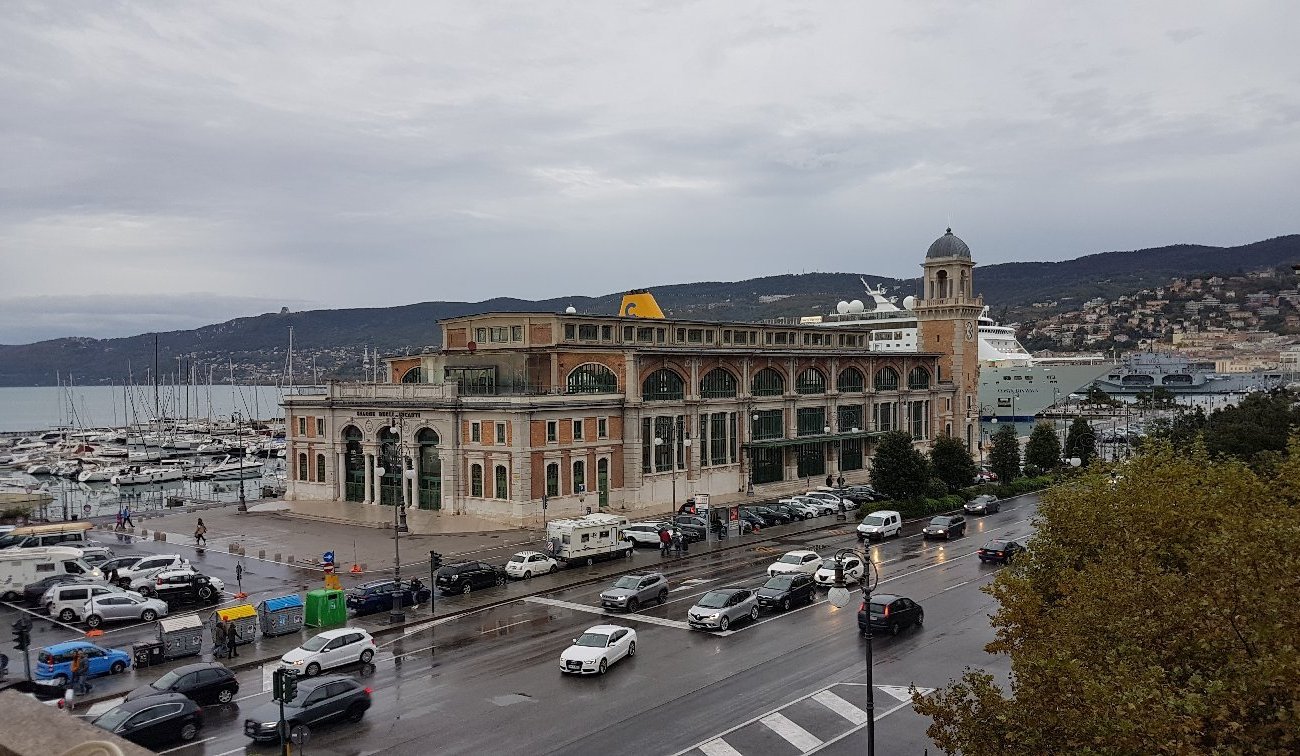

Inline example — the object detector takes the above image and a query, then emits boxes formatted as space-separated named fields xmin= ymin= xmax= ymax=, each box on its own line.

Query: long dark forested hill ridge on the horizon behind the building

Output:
xmin=0 ymin=235 xmax=1300 ymax=386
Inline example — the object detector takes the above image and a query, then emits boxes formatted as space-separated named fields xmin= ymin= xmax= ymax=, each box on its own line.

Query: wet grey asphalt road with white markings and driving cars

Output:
xmin=10 ymin=498 xmax=1035 ymax=756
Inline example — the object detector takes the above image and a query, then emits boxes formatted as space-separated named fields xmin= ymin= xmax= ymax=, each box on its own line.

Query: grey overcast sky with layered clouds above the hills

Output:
xmin=0 ymin=0 xmax=1300 ymax=344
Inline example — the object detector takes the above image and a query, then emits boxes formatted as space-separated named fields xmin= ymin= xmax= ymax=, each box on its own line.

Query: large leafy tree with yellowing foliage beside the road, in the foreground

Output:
xmin=913 ymin=436 xmax=1300 ymax=756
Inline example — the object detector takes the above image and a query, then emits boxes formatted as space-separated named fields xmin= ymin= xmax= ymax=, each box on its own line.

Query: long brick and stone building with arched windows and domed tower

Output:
xmin=285 ymin=231 xmax=983 ymax=531
